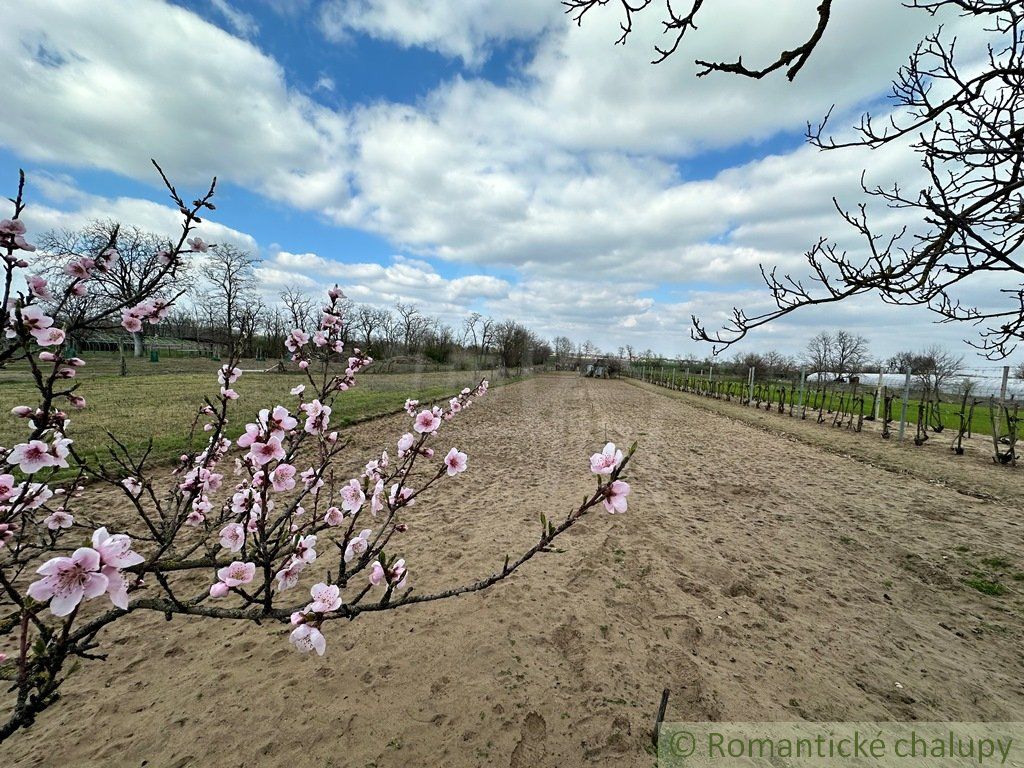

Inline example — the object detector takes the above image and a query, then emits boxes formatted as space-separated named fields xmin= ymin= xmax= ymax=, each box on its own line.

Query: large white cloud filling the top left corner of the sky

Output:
xmin=0 ymin=0 xmax=347 ymax=209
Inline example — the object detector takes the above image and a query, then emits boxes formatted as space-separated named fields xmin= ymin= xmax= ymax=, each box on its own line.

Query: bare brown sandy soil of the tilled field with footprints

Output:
xmin=8 ymin=376 xmax=1024 ymax=768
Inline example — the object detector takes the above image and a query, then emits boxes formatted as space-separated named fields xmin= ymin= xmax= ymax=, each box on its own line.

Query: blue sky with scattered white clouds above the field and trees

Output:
xmin=0 ymin=0 xmax=1007 ymax=364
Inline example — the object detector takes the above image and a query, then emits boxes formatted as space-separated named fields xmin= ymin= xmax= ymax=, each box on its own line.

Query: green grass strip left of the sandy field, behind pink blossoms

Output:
xmin=0 ymin=360 xmax=511 ymax=475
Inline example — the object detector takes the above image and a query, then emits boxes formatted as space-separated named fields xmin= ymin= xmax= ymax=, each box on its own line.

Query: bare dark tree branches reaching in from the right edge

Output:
xmin=679 ymin=0 xmax=1024 ymax=359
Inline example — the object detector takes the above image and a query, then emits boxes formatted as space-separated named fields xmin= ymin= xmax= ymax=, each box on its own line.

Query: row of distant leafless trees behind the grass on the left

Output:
xmin=39 ymin=219 xmax=553 ymax=369
